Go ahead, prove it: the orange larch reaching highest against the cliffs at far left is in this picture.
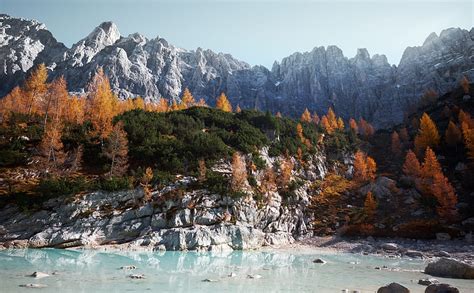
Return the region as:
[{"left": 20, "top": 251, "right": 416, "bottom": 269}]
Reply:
[{"left": 25, "top": 63, "right": 48, "bottom": 114}]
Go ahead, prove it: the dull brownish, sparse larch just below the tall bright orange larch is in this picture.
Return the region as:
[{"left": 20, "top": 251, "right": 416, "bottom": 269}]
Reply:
[{"left": 104, "top": 121, "right": 128, "bottom": 177}]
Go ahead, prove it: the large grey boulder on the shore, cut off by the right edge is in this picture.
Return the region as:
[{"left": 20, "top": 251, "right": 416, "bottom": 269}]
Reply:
[{"left": 425, "top": 258, "right": 474, "bottom": 279}]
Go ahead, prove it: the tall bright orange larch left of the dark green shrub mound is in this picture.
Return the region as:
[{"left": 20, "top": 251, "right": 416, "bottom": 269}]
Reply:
[{"left": 87, "top": 68, "right": 117, "bottom": 143}]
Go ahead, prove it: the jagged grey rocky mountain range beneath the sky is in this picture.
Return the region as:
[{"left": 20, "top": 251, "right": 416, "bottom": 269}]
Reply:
[{"left": 0, "top": 15, "right": 474, "bottom": 127}]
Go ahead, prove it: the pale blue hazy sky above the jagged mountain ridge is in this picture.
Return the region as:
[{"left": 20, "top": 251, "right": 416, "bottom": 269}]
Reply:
[{"left": 0, "top": 0, "right": 474, "bottom": 68}]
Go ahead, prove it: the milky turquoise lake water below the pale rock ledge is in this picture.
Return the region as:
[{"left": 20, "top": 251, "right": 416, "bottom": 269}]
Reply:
[{"left": 0, "top": 249, "right": 474, "bottom": 293}]
